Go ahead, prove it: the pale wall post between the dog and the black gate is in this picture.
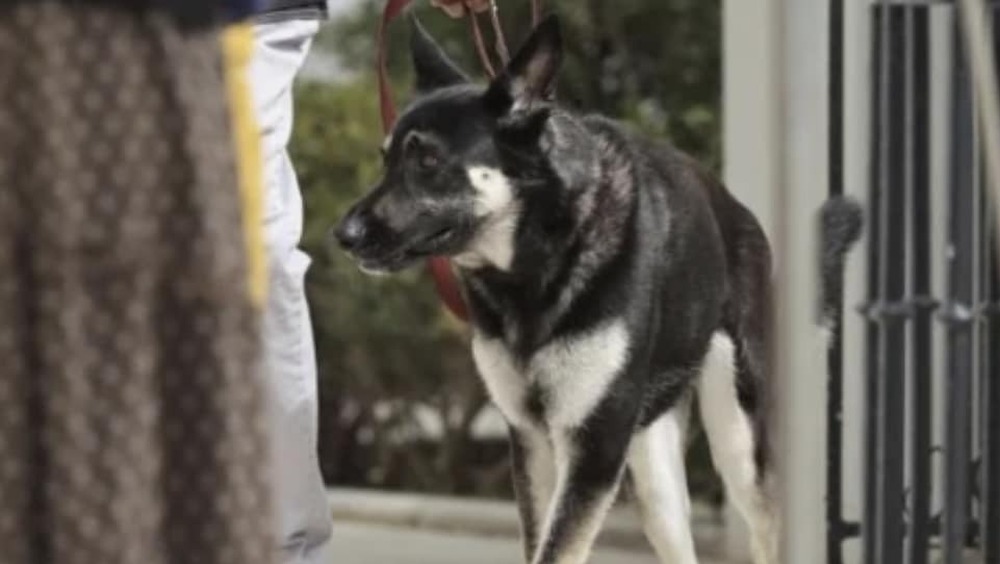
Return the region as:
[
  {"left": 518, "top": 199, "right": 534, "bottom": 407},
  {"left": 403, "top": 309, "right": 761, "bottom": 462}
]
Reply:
[{"left": 723, "top": 0, "right": 829, "bottom": 562}]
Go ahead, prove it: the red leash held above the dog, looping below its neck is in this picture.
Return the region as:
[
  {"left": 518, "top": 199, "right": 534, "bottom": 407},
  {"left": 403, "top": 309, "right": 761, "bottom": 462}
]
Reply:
[{"left": 375, "top": 0, "right": 540, "bottom": 321}]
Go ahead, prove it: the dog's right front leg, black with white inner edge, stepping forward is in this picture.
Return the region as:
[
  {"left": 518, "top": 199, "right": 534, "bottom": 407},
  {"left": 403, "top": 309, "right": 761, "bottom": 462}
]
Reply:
[{"left": 532, "top": 429, "right": 628, "bottom": 564}]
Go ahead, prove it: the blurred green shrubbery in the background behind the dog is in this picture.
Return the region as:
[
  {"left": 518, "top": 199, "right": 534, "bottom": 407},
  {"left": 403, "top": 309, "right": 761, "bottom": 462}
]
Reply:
[{"left": 292, "top": 0, "right": 722, "bottom": 505}]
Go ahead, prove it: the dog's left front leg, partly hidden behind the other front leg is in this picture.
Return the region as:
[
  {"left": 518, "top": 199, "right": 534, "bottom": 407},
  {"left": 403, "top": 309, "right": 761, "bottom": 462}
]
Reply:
[{"left": 510, "top": 427, "right": 556, "bottom": 562}]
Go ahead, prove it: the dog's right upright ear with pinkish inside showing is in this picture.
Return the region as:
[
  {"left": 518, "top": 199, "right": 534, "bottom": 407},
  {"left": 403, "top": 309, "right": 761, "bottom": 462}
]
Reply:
[{"left": 485, "top": 15, "right": 562, "bottom": 115}]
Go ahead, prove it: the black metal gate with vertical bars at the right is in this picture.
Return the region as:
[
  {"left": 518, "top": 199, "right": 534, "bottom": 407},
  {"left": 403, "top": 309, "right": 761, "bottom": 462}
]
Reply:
[{"left": 827, "top": 0, "right": 1000, "bottom": 564}]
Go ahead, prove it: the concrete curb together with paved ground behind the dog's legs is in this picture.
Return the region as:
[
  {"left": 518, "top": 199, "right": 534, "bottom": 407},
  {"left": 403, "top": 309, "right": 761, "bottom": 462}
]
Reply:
[{"left": 329, "top": 488, "right": 746, "bottom": 564}]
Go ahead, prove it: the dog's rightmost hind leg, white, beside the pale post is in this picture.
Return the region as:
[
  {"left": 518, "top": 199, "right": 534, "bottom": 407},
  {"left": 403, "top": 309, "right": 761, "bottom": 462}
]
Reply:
[{"left": 698, "top": 333, "right": 778, "bottom": 564}]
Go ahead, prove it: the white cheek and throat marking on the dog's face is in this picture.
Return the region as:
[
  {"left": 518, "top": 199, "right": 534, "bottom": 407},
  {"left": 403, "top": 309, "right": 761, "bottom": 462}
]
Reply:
[{"left": 455, "top": 166, "right": 520, "bottom": 270}]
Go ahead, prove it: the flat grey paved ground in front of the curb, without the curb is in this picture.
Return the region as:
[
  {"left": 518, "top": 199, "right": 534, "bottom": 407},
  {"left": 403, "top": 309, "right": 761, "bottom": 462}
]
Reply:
[{"left": 333, "top": 522, "right": 720, "bottom": 564}]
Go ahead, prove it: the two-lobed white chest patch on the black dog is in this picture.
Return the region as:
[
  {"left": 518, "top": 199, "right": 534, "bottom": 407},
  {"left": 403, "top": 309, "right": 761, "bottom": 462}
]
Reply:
[{"left": 472, "top": 320, "right": 629, "bottom": 429}]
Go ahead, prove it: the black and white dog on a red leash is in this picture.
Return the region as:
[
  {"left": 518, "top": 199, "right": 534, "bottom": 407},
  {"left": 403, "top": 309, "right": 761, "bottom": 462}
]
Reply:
[{"left": 334, "top": 14, "right": 850, "bottom": 564}]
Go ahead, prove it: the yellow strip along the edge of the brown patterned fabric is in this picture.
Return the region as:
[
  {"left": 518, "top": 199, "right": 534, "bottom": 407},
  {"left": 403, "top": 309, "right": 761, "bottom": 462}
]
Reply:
[{"left": 222, "top": 24, "right": 267, "bottom": 306}]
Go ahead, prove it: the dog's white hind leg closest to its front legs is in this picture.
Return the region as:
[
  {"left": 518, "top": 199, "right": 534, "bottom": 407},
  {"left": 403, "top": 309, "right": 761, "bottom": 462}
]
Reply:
[{"left": 628, "top": 399, "right": 698, "bottom": 564}]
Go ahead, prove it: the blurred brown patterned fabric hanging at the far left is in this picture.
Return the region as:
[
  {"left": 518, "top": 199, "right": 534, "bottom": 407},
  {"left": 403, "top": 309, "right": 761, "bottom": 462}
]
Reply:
[{"left": 0, "top": 1, "right": 273, "bottom": 564}]
